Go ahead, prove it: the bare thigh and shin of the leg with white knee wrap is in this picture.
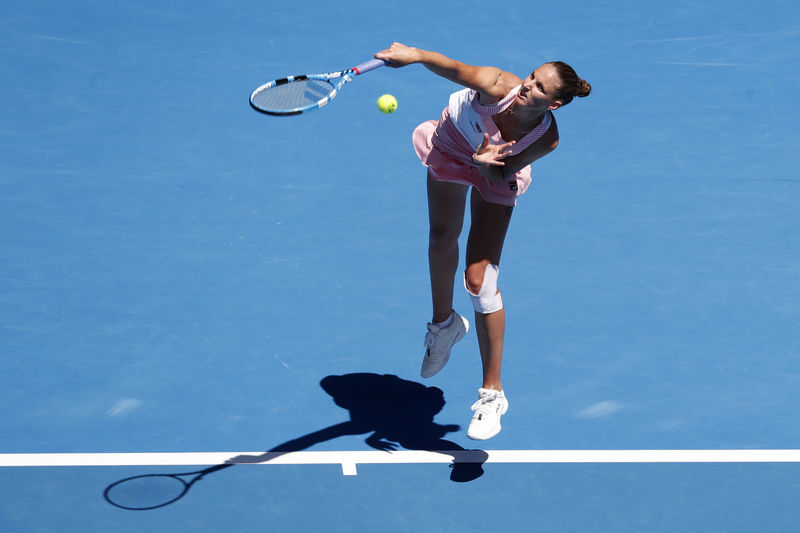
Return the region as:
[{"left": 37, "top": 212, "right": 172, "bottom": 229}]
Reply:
[{"left": 464, "top": 190, "right": 513, "bottom": 390}]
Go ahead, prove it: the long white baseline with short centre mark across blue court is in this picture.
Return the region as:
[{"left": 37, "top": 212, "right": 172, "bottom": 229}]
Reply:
[{"left": 0, "top": 450, "right": 800, "bottom": 476}]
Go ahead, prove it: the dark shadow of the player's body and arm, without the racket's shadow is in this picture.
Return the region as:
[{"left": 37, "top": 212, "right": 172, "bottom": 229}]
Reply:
[{"left": 231, "top": 373, "right": 488, "bottom": 482}]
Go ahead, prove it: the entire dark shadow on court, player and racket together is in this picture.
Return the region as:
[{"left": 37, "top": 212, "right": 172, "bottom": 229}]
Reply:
[{"left": 103, "top": 373, "right": 488, "bottom": 511}]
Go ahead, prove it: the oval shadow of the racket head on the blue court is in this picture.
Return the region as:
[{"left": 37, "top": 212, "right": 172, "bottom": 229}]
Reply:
[{"left": 103, "top": 474, "right": 196, "bottom": 511}]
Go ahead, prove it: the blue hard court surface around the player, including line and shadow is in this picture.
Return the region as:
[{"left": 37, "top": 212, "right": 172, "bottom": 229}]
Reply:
[{"left": 0, "top": 0, "right": 800, "bottom": 533}]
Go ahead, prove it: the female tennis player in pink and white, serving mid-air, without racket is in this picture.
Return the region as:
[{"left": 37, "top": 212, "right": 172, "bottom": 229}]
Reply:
[{"left": 375, "top": 43, "right": 591, "bottom": 440}]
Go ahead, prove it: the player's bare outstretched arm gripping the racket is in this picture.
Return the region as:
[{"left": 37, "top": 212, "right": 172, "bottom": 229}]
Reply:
[{"left": 375, "top": 43, "right": 522, "bottom": 104}]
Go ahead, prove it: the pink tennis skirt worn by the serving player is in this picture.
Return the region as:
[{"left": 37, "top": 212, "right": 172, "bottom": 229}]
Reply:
[{"left": 412, "top": 108, "right": 531, "bottom": 207}]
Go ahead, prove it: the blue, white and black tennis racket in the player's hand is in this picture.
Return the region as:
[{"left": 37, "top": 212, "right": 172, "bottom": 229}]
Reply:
[{"left": 250, "top": 59, "right": 386, "bottom": 116}]
